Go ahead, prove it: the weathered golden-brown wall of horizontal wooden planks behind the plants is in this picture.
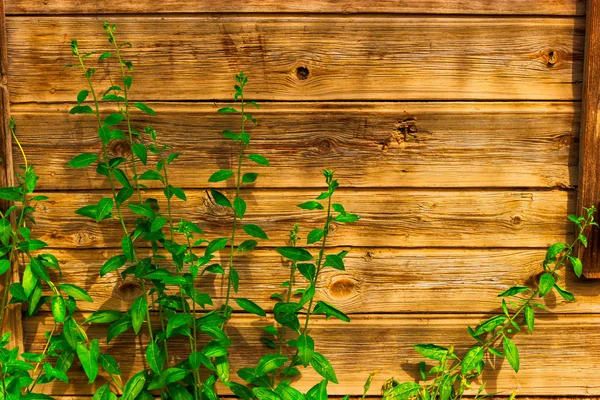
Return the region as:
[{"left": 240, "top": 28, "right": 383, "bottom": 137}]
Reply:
[{"left": 5, "top": 0, "right": 600, "bottom": 399}]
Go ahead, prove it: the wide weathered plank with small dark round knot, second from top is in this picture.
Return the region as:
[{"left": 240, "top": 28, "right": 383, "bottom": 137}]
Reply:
[{"left": 8, "top": 15, "right": 584, "bottom": 102}]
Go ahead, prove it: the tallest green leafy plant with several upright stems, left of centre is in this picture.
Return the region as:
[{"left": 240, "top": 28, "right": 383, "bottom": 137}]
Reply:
[{"left": 62, "top": 23, "right": 358, "bottom": 400}]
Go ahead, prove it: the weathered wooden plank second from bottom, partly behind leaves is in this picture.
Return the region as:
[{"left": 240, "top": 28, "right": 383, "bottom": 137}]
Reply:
[{"left": 29, "top": 248, "right": 600, "bottom": 314}]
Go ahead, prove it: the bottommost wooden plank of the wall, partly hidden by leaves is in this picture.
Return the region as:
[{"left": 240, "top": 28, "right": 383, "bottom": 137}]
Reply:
[{"left": 25, "top": 312, "right": 600, "bottom": 396}]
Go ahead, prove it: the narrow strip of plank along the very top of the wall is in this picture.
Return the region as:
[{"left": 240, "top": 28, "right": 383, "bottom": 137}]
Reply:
[{"left": 7, "top": 0, "right": 585, "bottom": 15}]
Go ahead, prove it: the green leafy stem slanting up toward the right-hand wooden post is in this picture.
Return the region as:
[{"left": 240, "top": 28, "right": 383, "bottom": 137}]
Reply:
[{"left": 383, "top": 207, "right": 598, "bottom": 400}]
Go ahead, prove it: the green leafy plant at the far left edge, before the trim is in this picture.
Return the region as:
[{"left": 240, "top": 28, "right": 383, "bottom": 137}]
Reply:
[{"left": 0, "top": 119, "right": 121, "bottom": 399}]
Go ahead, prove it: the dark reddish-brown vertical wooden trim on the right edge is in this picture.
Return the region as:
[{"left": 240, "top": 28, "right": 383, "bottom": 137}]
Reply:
[{"left": 577, "top": 0, "right": 600, "bottom": 278}]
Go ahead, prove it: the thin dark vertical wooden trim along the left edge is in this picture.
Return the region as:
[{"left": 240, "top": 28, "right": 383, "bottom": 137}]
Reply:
[{"left": 0, "top": 0, "right": 23, "bottom": 350}]
